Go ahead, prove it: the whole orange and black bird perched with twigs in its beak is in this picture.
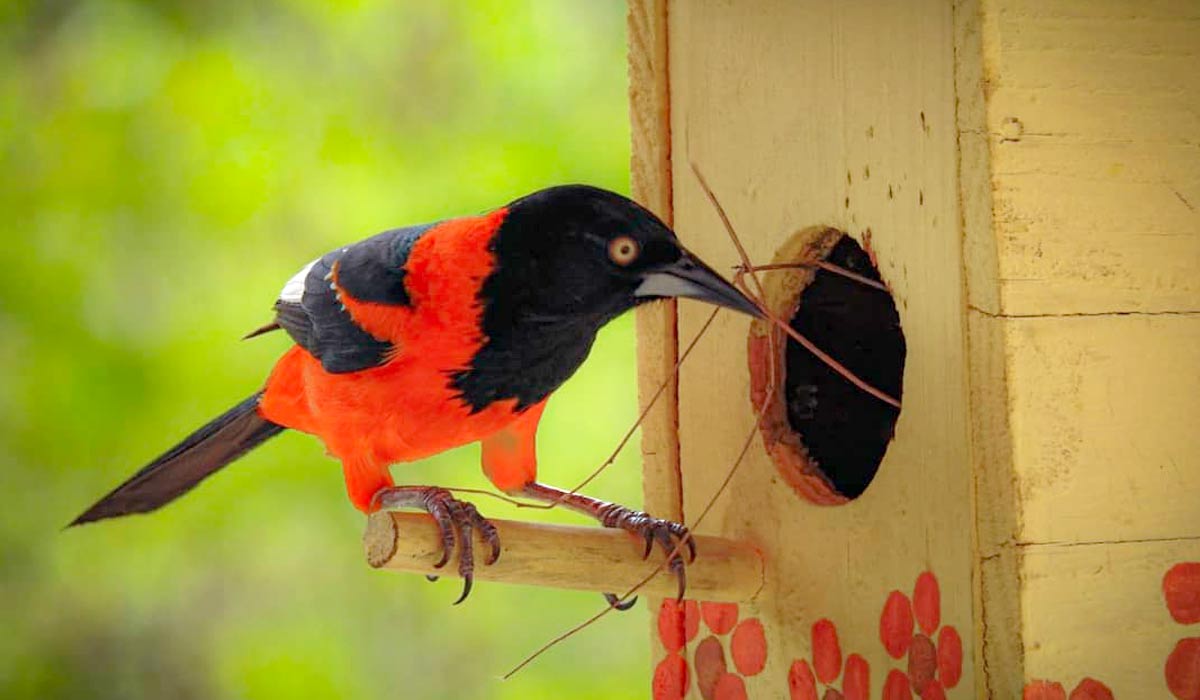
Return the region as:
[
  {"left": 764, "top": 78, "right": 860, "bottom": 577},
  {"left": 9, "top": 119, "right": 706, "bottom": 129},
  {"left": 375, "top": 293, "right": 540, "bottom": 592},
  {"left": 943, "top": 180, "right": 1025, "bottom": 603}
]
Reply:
[{"left": 71, "top": 185, "right": 761, "bottom": 600}]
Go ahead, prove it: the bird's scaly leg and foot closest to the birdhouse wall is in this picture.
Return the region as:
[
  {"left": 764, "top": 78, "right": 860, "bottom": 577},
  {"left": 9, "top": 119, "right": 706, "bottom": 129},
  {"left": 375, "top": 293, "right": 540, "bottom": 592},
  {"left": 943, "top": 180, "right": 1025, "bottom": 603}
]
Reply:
[{"left": 520, "top": 481, "right": 696, "bottom": 604}]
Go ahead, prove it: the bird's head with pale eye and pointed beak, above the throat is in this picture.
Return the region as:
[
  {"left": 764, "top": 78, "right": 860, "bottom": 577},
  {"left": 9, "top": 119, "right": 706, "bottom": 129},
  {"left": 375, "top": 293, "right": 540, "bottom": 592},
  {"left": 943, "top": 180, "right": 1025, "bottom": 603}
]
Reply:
[{"left": 494, "top": 185, "right": 761, "bottom": 323}]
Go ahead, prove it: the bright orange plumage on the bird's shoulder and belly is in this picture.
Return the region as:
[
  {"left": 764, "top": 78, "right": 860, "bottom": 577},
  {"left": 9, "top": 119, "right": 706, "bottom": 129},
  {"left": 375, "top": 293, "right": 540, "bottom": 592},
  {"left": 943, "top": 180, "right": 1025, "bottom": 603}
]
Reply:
[{"left": 259, "top": 209, "right": 528, "bottom": 466}]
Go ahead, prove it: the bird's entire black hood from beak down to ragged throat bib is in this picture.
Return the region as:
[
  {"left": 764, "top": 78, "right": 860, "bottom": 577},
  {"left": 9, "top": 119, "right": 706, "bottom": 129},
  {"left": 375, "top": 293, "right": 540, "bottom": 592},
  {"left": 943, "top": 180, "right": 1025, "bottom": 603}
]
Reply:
[{"left": 455, "top": 185, "right": 760, "bottom": 409}]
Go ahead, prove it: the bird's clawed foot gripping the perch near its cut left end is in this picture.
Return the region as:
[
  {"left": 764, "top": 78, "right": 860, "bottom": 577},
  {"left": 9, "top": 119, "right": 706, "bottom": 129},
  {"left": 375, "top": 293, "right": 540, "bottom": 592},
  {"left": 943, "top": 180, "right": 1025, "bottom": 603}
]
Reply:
[{"left": 371, "top": 486, "right": 500, "bottom": 605}]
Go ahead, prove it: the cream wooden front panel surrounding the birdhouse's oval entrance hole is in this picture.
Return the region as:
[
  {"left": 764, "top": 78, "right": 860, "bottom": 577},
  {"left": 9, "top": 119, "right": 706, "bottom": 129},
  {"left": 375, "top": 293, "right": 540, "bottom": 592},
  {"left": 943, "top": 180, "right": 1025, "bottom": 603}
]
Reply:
[{"left": 668, "top": 0, "right": 976, "bottom": 698}]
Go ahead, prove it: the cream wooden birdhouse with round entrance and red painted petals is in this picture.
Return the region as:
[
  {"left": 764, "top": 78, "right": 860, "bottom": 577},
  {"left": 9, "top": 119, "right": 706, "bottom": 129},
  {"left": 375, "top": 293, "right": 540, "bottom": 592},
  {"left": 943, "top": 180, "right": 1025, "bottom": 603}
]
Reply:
[{"left": 368, "top": 0, "right": 1200, "bottom": 700}]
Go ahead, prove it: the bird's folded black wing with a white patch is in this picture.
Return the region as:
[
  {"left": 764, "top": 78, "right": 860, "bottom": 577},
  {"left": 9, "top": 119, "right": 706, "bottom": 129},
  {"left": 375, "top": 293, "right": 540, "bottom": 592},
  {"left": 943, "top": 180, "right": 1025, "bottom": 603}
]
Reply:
[{"left": 275, "top": 225, "right": 433, "bottom": 373}]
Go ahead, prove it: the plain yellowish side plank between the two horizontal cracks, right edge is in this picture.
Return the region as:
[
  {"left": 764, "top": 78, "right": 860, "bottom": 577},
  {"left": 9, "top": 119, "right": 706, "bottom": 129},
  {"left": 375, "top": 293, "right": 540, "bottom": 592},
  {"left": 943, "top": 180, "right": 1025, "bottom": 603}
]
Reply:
[{"left": 1006, "top": 313, "right": 1200, "bottom": 543}]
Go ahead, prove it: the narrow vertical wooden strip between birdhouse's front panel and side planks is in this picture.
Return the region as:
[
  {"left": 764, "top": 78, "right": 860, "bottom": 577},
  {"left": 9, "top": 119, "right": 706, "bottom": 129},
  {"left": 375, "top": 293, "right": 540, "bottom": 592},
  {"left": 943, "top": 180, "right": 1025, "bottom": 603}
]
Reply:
[{"left": 954, "top": 0, "right": 1025, "bottom": 698}]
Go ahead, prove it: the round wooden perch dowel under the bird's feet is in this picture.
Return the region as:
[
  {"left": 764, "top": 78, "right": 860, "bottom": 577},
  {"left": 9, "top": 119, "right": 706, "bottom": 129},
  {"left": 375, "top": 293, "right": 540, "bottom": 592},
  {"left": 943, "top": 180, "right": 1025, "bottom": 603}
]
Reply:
[{"left": 362, "top": 513, "right": 763, "bottom": 603}]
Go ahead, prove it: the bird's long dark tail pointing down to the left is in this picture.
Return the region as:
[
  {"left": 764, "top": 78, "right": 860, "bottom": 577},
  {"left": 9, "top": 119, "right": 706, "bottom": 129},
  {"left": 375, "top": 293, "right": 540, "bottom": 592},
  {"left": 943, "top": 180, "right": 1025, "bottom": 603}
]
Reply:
[{"left": 68, "top": 391, "right": 283, "bottom": 527}]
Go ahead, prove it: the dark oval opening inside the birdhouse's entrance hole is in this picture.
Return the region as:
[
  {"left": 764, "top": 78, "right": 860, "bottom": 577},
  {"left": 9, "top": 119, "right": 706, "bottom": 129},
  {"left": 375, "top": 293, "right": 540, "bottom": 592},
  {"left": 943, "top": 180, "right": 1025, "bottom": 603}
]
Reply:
[{"left": 784, "top": 235, "right": 905, "bottom": 498}]
